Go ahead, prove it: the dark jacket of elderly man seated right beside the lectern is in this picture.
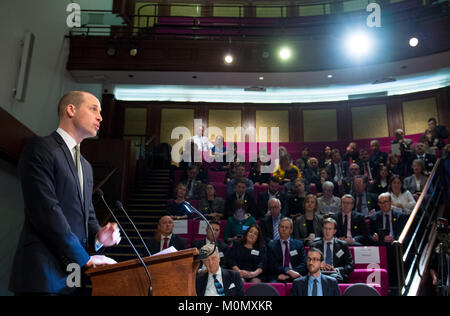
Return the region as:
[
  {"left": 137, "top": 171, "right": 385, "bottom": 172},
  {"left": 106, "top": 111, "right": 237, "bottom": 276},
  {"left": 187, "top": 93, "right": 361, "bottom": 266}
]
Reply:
[{"left": 196, "top": 269, "right": 245, "bottom": 296}]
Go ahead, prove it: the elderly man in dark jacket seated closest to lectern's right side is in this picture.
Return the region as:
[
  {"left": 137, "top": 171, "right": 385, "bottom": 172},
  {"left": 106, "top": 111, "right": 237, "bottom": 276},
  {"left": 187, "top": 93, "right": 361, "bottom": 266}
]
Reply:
[{"left": 196, "top": 244, "right": 244, "bottom": 296}]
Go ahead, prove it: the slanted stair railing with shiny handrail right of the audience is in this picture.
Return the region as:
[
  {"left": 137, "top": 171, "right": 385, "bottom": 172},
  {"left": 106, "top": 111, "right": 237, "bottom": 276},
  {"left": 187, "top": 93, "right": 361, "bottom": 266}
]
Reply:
[{"left": 394, "top": 159, "right": 442, "bottom": 295}]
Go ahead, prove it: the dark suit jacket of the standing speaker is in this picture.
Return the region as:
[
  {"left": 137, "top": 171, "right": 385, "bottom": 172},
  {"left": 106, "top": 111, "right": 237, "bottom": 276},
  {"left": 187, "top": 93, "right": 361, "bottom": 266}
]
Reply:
[{"left": 9, "top": 132, "right": 100, "bottom": 294}]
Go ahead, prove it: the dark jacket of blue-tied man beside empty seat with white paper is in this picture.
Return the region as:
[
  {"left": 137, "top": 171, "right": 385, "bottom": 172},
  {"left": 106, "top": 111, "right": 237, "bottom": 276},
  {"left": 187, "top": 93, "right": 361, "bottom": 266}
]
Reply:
[{"left": 312, "top": 238, "right": 353, "bottom": 282}]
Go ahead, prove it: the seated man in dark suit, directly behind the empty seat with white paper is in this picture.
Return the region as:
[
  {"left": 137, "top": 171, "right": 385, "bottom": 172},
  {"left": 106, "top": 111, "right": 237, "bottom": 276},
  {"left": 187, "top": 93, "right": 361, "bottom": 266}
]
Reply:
[{"left": 334, "top": 194, "right": 369, "bottom": 246}]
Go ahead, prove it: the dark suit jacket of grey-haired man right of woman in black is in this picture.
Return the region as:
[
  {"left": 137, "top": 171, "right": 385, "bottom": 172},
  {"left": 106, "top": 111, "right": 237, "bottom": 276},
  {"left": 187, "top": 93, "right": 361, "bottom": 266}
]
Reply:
[{"left": 267, "top": 238, "right": 306, "bottom": 279}]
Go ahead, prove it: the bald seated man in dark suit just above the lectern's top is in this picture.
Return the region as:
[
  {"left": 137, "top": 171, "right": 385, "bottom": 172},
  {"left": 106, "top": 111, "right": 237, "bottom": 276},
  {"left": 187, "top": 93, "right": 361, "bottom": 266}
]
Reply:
[{"left": 146, "top": 216, "right": 187, "bottom": 254}]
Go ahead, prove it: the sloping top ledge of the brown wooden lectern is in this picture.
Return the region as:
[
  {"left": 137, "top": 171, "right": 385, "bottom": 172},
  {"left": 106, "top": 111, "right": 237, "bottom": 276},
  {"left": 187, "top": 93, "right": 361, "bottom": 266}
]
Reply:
[{"left": 86, "top": 248, "right": 199, "bottom": 276}]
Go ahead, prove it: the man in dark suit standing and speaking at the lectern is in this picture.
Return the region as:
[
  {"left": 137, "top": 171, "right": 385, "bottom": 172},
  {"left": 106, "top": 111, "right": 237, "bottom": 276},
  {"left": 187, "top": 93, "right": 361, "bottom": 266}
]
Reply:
[{"left": 9, "top": 91, "right": 120, "bottom": 295}]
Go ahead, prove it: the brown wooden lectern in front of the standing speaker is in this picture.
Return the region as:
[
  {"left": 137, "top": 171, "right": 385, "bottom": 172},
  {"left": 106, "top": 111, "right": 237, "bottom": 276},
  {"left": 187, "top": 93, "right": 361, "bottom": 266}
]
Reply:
[{"left": 86, "top": 248, "right": 200, "bottom": 296}]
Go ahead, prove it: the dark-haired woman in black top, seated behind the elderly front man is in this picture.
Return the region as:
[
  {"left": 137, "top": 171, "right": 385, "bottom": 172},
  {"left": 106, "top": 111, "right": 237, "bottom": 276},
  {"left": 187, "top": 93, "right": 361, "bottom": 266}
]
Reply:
[{"left": 227, "top": 224, "right": 266, "bottom": 283}]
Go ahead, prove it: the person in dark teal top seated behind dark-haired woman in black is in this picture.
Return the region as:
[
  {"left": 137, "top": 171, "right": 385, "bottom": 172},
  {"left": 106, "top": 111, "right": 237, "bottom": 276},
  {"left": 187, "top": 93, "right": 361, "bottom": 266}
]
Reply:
[{"left": 224, "top": 200, "right": 256, "bottom": 244}]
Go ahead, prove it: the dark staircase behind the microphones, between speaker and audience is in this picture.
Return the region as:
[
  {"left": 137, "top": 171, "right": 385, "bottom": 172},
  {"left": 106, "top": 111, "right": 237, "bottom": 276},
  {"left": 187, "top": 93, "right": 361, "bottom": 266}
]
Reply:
[{"left": 104, "top": 169, "right": 171, "bottom": 262}]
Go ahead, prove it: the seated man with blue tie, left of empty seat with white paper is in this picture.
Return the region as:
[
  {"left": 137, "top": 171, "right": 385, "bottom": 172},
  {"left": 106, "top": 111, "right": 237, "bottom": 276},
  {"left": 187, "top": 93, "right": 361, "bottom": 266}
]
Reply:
[{"left": 312, "top": 218, "right": 353, "bottom": 283}]
